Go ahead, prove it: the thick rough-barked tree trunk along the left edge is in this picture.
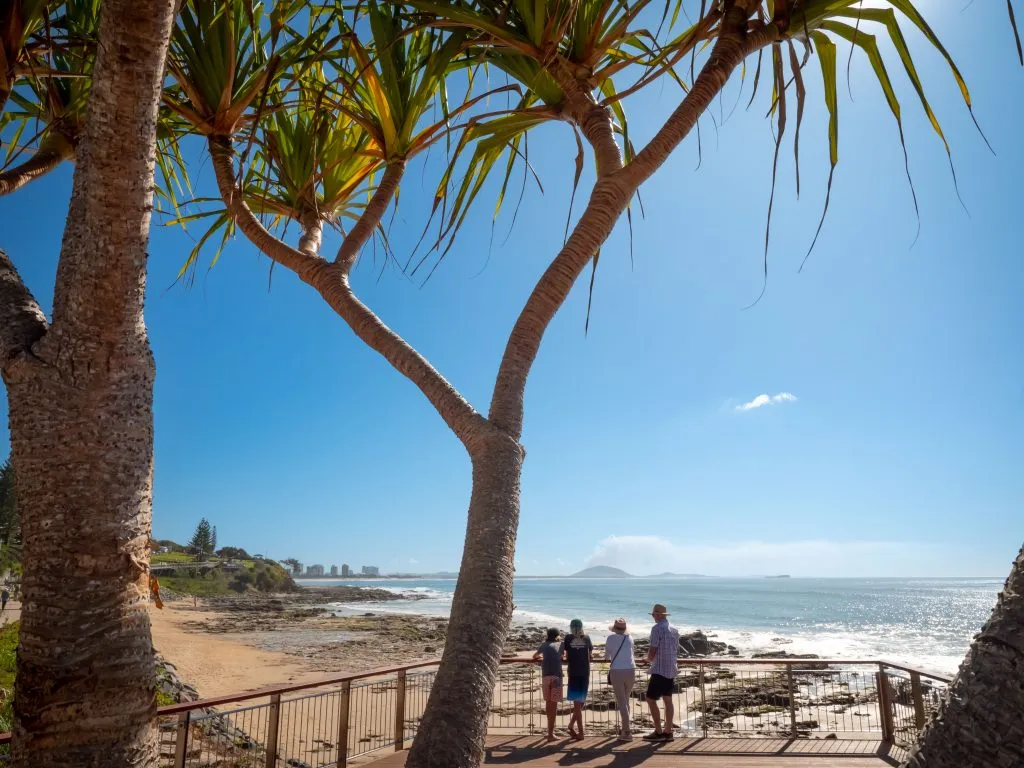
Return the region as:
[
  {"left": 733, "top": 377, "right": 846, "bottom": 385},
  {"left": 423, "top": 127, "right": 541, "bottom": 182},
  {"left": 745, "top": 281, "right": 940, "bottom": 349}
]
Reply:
[{"left": 0, "top": 0, "right": 173, "bottom": 768}]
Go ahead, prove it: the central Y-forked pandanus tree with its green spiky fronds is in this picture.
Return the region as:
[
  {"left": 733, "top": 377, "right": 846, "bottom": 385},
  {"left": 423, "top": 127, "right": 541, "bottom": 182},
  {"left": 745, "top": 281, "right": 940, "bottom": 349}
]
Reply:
[{"left": 159, "top": 0, "right": 1020, "bottom": 768}]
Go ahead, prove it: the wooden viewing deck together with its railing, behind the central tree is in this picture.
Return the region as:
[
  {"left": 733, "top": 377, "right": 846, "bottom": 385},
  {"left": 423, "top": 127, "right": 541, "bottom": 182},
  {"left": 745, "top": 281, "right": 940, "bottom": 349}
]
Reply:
[{"left": 125, "top": 656, "right": 949, "bottom": 768}]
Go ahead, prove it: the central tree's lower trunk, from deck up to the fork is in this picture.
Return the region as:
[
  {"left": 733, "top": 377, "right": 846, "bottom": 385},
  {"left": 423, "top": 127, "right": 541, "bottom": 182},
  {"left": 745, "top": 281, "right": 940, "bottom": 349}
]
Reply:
[{"left": 406, "top": 431, "right": 522, "bottom": 768}]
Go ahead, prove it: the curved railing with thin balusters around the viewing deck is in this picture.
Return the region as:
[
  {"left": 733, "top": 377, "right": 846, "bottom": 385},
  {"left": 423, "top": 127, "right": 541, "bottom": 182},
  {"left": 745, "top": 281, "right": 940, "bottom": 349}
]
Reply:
[{"left": 140, "top": 657, "right": 950, "bottom": 768}]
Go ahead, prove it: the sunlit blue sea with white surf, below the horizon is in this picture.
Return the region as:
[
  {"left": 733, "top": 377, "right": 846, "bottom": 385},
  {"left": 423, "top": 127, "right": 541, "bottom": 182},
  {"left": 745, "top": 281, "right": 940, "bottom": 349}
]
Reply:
[{"left": 304, "top": 578, "right": 1002, "bottom": 674}]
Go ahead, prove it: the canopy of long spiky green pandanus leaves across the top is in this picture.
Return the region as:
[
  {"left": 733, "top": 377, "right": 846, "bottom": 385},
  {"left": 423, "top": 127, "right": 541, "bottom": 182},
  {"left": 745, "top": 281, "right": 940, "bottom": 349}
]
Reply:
[{"left": 0, "top": 0, "right": 1024, "bottom": 275}]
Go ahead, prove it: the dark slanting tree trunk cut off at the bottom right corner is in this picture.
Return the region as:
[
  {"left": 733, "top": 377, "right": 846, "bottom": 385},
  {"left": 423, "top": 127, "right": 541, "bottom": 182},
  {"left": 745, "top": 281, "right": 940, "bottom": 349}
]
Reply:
[{"left": 903, "top": 548, "right": 1024, "bottom": 768}]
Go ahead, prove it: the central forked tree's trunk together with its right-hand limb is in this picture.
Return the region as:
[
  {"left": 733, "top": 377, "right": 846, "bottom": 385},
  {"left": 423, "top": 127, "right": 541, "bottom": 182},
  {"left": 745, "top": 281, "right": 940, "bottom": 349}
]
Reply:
[{"left": 399, "top": 10, "right": 772, "bottom": 768}]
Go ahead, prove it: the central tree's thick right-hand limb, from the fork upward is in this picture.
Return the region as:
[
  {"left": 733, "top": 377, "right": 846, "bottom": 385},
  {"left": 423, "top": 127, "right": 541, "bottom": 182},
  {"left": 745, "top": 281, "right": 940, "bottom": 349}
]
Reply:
[{"left": 488, "top": 0, "right": 770, "bottom": 440}]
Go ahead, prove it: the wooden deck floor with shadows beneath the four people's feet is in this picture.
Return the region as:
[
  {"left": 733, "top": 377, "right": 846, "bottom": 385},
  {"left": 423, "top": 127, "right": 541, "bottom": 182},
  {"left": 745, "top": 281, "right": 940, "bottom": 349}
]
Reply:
[{"left": 361, "top": 736, "right": 904, "bottom": 768}]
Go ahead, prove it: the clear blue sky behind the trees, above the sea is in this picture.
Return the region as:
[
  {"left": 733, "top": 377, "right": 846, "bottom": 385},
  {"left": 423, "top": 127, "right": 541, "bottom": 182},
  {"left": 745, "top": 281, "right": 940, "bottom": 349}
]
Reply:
[{"left": 0, "top": 2, "right": 1024, "bottom": 575}]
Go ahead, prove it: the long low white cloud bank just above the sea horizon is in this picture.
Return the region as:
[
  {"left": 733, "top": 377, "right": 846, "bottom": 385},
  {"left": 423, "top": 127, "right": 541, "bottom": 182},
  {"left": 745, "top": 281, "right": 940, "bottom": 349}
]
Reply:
[{"left": 587, "top": 536, "right": 949, "bottom": 577}]
